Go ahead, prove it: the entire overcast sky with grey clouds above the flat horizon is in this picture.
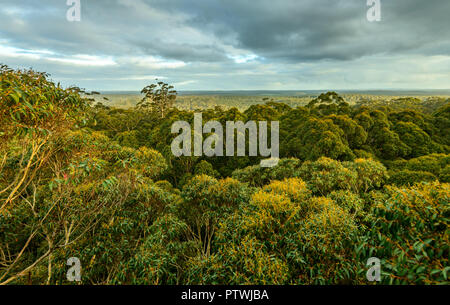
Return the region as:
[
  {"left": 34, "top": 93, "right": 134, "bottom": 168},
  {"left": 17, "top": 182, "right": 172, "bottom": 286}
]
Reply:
[{"left": 0, "top": 0, "right": 450, "bottom": 91}]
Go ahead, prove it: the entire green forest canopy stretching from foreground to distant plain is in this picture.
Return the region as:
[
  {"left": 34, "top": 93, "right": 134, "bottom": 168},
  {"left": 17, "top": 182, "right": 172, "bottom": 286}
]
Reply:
[{"left": 0, "top": 66, "right": 450, "bottom": 284}]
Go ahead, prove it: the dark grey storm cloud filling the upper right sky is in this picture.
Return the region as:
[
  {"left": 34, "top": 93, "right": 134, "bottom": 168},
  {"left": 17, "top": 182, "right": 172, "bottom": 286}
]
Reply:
[{"left": 132, "top": 0, "right": 450, "bottom": 61}]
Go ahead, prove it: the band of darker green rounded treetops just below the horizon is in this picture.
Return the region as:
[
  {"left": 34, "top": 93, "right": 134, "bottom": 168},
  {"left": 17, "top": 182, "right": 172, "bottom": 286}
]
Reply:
[{"left": 92, "top": 92, "right": 450, "bottom": 185}]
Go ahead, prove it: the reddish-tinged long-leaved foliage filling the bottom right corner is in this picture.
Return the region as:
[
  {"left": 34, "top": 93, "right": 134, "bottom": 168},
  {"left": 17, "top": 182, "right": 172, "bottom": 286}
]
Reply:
[{"left": 363, "top": 182, "right": 450, "bottom": 284}]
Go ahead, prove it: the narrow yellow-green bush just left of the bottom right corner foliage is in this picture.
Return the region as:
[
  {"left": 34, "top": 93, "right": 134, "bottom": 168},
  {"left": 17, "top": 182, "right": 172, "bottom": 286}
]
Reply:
[{"left": 295, "top": 197, "right": 358, "bottom": 284}]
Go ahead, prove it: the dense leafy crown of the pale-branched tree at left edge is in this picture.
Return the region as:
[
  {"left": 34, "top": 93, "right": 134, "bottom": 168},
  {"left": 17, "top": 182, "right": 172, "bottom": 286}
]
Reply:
[{"left": 0, "top": 65, "right": 89, "bottom": 142}]
